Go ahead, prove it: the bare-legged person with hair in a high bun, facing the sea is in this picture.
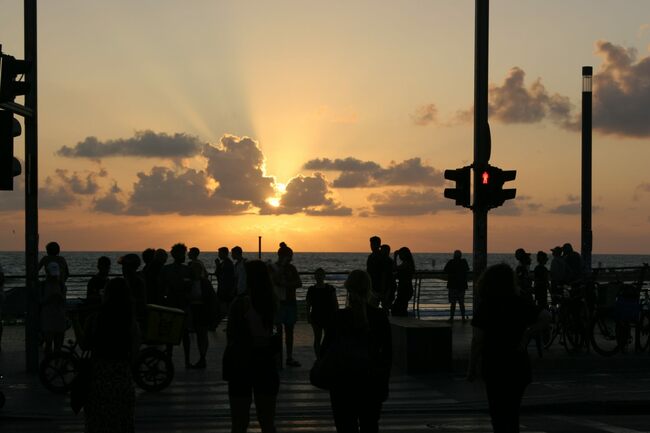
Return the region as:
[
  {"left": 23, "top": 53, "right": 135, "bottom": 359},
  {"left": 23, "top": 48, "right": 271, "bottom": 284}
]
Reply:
[{"left": 268, "top": 242, "right": 302, "bottom": 367}]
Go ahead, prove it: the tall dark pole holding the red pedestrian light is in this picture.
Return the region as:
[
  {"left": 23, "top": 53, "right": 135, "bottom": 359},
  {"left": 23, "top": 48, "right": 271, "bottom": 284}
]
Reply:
[{"left": 473, "top": 0, "right": 490, "bottom": 300}]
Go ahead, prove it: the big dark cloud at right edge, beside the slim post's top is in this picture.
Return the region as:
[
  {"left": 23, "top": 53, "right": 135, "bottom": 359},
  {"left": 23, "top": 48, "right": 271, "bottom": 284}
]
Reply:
[{"left": 593, "top": 41, "right": 650, "bottom": 138}]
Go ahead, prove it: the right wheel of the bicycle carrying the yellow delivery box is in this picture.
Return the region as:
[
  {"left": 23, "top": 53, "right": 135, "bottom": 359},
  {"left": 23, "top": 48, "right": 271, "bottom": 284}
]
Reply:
[{"left": 133, "top": 347, "right": 174, "bottom": 392}]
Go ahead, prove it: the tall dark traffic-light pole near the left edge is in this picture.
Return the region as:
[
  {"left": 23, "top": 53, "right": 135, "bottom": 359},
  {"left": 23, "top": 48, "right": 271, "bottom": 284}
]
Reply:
[{"left": 24, "top": 0, "right": 39, "bottom": 373}]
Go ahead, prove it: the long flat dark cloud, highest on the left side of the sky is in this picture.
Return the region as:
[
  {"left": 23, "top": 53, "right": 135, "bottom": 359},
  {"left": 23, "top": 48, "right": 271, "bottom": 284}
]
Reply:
[{"left": 57, "top": 130, "right": 203, "bottom": 160}]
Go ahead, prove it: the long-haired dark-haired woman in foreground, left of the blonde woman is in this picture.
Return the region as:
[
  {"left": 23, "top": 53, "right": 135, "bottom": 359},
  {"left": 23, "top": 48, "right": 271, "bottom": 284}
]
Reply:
[{"left": 223, "top": 260, "right": 280, "bottom": 433}]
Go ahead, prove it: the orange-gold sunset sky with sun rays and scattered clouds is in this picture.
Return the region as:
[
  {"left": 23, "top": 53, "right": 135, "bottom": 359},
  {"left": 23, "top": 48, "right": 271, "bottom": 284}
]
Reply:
[{"left": 0, "top": 0, "right": 650, "bottom": 253}]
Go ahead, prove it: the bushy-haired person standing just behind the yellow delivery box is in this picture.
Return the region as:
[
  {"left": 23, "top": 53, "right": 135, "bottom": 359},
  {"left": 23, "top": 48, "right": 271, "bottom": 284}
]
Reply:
[{"left": 159, "top": 243, "right": 192, "bottom": 368}]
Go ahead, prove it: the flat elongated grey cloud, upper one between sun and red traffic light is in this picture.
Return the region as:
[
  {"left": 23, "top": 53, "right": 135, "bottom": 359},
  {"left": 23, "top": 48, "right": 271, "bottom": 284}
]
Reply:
[{"left": 304, "top": 157, "right": 444, "bottom": 188}]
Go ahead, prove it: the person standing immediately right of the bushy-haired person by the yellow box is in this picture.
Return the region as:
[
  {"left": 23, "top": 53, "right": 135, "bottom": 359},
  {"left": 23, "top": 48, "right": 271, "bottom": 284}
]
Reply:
[{"left": 190, "top": 261, "right": 216, "bottom": 369}]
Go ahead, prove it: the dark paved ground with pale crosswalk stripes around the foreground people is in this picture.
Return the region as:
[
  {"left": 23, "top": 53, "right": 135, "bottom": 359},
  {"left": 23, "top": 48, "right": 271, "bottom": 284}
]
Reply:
[{"left": 0, "top": 322, "right": 650, "bottom": 432}]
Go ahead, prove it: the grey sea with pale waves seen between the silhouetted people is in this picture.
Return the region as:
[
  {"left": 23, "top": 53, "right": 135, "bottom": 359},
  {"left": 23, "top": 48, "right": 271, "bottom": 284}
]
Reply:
[{"left": 0, "top": 251, "right": 650, "bottom": 319}]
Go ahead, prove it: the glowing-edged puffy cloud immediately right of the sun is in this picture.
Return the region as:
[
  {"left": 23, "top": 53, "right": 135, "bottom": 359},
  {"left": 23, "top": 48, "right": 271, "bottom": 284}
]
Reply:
[{"left": 262, "top": 173, "right": 352, "bottom": 216}]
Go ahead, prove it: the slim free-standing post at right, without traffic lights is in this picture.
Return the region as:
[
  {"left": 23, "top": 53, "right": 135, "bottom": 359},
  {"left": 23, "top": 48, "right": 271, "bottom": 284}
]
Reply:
[{"left": 580, "top": 66, "right": 593, "bottom": 274}]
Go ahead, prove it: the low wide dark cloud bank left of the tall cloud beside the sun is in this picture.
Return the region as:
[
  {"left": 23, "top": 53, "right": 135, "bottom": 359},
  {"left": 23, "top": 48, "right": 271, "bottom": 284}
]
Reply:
[{"left": 125, "top": 167, "right": 249, "bottom": 215}]
